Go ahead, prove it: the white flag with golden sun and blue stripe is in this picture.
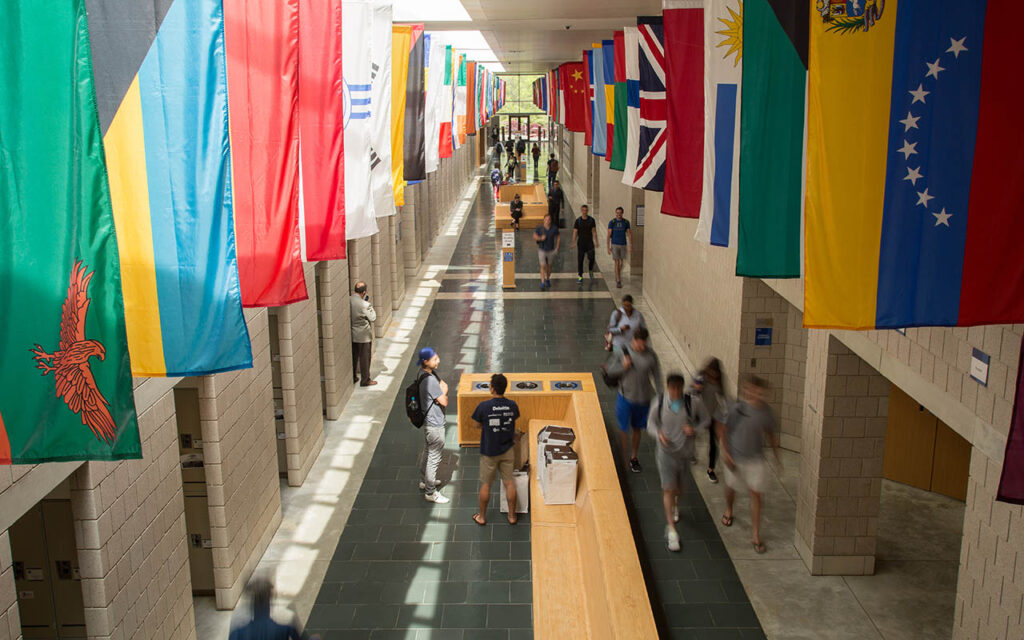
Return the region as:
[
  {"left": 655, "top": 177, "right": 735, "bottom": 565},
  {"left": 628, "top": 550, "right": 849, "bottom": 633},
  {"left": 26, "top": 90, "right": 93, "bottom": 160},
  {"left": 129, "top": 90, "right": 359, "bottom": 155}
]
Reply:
[{"left": 693, "top": 0, "right": 743, "bottom": 247}]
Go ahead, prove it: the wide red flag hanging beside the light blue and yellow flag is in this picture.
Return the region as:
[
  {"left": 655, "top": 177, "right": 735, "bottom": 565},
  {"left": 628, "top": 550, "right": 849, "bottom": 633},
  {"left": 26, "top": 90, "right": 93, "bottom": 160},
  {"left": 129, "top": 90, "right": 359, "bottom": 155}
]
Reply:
[{"left": 224, "top": 0, "right": 309, "bottom": 307}]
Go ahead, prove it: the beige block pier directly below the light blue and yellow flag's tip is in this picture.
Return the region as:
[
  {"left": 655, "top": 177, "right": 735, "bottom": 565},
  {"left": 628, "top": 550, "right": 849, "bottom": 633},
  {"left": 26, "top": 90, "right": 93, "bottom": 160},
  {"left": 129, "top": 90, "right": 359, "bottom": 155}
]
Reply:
[{"left": 195, "top": 309, "right": 281, "bottom": 609}]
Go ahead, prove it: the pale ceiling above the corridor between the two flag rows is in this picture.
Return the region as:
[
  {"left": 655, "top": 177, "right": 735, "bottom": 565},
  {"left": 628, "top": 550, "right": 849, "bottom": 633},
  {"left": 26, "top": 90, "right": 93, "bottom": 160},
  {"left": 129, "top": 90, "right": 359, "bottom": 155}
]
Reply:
[{"left": 395, "top": 0, "right": 662, "bottom": 74}]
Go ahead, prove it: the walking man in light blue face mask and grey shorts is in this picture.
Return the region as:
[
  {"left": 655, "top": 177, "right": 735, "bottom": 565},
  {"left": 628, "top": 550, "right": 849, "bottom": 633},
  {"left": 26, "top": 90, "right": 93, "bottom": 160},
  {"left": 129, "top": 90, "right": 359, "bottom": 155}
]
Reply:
[{"left": 647, "top": 374, "right": 711, "bottom": 551}]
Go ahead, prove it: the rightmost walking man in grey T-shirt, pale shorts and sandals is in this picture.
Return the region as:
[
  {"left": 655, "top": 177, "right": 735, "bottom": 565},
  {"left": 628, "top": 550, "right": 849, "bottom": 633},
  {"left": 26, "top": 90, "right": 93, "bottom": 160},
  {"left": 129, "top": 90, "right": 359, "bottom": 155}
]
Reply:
[{"left": 718, "top": 376, "right": 782, "bottom": 553}]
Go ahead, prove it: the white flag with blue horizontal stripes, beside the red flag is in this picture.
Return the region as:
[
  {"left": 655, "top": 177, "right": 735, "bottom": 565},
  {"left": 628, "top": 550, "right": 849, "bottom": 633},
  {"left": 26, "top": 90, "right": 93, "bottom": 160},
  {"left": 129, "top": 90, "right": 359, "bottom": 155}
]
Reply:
[{"left": 341, "top": 0, "right": 379, "bottom": 240}]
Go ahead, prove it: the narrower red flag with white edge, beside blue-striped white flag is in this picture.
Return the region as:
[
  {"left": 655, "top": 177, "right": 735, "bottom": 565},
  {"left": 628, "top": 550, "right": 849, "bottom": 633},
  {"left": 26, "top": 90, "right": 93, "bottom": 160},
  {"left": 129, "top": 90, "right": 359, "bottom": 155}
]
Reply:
[{"left": 298, "top": 0, "right": 345, "bottom": 260}]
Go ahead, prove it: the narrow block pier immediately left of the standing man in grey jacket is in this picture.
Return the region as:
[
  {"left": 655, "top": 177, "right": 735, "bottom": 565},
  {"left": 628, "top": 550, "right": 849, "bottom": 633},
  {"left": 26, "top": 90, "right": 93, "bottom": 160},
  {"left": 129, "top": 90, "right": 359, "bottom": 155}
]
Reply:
[{"left": 316, "top": 260, "right": 352, "bottom": 420}]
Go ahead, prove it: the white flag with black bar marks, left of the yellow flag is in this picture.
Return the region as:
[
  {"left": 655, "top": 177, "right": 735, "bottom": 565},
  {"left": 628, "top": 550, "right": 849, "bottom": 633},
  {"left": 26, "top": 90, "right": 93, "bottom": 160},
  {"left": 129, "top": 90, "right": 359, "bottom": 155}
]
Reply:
[{"left": 370, "top": 0, "right": 393, "bottom": 218}]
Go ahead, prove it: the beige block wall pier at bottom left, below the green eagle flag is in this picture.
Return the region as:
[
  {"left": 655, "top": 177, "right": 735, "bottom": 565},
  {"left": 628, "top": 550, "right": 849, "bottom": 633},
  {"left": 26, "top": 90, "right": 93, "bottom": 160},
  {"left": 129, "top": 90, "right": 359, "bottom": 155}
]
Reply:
[{"left": 71, "top": 389, "right": 196, "bottom": 639}]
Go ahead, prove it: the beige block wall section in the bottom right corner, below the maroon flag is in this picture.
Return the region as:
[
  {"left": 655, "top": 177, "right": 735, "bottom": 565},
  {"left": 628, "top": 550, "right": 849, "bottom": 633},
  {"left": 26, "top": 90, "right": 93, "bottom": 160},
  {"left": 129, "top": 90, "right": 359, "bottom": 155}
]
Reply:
[{"left": 953, "top": 447, "right": 1024, "bottom": 640}]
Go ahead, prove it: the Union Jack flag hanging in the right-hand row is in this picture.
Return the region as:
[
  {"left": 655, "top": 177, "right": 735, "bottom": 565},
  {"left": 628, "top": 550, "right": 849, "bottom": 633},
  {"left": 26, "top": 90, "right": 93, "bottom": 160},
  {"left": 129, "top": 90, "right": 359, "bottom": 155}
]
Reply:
[{"left": 635, "top": 16, "right": 668, "bottom": 191}]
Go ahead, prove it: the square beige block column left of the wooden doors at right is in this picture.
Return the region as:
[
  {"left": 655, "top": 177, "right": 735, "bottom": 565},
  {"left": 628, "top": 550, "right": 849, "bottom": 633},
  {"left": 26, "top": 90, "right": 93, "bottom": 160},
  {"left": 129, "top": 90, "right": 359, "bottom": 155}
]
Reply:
[{"left": 796, "top": 331, "right": 890, "bottom": 575}]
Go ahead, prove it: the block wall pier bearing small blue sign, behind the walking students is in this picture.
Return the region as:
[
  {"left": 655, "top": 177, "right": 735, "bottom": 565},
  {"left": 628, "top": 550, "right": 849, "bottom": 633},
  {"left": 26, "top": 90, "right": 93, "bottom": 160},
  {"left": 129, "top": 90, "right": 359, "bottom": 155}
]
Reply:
[{"left": 739, "top": 278, "right": 807, "bottom": 452}]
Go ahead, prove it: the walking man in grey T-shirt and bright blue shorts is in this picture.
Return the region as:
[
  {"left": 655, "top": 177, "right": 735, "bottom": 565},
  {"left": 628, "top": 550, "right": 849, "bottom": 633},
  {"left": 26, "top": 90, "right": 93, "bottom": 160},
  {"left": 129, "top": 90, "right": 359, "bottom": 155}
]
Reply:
[{"left": 608, "top": 327, "right": 664, "bottom": 473}]
